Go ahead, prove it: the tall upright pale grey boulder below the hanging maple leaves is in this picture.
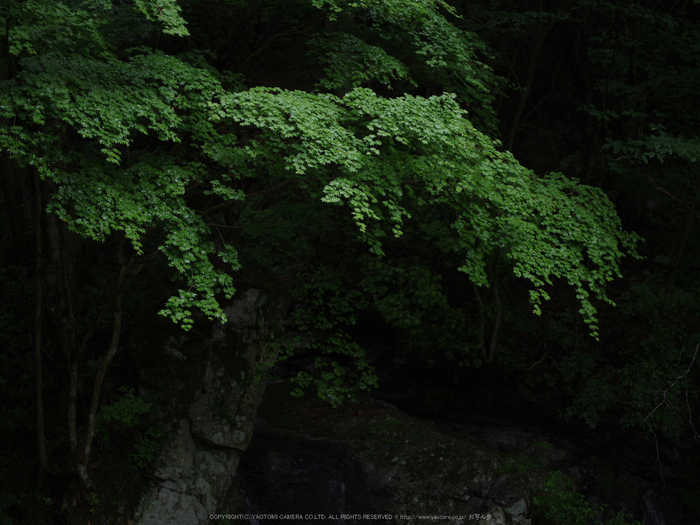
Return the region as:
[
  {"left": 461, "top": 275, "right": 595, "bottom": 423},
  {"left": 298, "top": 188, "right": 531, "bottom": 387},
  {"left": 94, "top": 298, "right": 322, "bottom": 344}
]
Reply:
[{"left": 129, "top": 288, "right": 286, "bottom": 525}]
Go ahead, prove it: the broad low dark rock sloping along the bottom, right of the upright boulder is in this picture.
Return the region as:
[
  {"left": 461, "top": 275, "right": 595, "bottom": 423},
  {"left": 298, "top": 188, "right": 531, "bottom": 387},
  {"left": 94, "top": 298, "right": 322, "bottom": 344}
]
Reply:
[{"left": 238, "top": 381, "right": 676, "bottom": 525}]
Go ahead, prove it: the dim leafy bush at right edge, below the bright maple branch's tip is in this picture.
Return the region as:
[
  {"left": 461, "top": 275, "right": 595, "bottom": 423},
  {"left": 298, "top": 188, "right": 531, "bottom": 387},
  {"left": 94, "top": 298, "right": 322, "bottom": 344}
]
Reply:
[{"left": 559, "top": 273, "right": 700, "bottom": 436}]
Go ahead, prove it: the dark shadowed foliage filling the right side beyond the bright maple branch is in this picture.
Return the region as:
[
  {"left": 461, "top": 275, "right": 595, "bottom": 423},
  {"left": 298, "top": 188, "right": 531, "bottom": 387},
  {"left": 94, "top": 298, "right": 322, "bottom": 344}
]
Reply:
[{"left": 455, "top": 0, "right": 700, "bottom": 435}]
